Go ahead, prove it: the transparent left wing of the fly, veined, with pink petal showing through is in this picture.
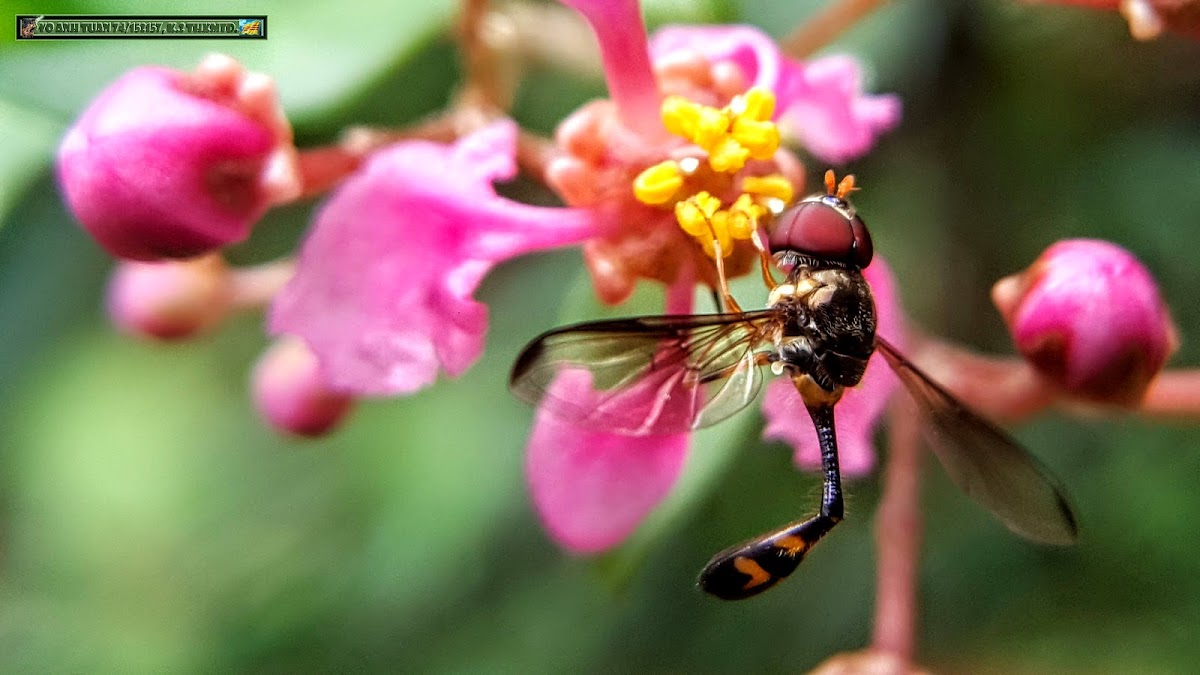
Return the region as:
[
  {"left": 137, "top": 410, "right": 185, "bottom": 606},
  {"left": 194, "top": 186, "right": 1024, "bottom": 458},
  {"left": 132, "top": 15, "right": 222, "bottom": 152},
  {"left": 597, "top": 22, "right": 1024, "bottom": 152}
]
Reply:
[{"left": 509, "top": 310, "right": 776, "bottom": 436}]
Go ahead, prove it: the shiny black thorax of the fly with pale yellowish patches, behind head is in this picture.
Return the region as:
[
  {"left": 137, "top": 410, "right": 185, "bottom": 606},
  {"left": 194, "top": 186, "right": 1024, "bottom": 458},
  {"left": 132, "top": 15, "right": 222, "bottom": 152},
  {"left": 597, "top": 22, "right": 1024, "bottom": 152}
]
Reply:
[{"left": 772, "top": 265, "right": 875, "bottom": 390}]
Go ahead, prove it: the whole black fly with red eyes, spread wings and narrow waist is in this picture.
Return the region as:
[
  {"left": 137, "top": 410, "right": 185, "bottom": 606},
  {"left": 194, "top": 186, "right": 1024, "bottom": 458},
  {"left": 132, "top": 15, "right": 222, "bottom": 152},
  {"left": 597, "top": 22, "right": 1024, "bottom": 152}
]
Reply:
[{"left": 510, "top": 172, "right": 1076, "bottom": 599}]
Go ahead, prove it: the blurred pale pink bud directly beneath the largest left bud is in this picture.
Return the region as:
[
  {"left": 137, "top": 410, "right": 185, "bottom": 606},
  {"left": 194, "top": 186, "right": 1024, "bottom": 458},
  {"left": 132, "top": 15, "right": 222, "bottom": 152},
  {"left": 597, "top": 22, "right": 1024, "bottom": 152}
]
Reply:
[{"left": 108, "top": 256, "right": 232, "bottom": 340}]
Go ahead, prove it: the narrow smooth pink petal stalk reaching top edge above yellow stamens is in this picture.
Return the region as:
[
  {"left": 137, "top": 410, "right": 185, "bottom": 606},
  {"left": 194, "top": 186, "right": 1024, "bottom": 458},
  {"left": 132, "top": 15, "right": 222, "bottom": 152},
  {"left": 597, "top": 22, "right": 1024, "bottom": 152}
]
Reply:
[{"left": 563, "top": 0, "right": 664, "bottom": 138}]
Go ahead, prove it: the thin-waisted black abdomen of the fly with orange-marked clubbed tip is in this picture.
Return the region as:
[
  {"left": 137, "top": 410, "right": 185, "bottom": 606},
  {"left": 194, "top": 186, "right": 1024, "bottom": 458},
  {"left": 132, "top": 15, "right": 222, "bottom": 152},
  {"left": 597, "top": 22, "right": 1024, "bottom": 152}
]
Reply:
[{"left": 700, "top": 405, "right": 845, "bottom": 601}]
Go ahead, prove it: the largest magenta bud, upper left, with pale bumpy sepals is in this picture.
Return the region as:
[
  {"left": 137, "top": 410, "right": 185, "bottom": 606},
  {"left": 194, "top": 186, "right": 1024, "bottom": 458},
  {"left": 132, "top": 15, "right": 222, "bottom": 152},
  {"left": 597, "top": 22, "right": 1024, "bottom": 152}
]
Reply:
[{"left": 58, "top": 55, "right": 300, "bottom": 261}]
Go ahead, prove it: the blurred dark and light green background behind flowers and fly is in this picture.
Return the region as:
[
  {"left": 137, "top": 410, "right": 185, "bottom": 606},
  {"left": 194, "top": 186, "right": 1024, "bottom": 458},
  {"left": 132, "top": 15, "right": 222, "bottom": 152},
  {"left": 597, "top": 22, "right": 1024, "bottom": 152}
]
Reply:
[{"left": 0, "top": 0, "right": 1200, "bottom": 673}]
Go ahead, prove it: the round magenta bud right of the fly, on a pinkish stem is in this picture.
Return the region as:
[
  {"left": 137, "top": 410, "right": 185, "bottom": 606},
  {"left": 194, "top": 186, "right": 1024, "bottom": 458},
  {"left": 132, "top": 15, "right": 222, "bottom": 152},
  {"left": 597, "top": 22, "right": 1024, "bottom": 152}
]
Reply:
[{"left": 991, "top": 239, "right": 1178, "bottom": 406}]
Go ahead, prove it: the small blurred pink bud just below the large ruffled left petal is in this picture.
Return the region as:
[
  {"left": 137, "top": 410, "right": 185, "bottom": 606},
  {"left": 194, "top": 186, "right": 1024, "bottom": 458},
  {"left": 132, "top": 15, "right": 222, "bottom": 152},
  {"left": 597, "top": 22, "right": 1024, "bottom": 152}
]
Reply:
[{"left": 251, "top": 336, "right": 354, "bottom": 436}]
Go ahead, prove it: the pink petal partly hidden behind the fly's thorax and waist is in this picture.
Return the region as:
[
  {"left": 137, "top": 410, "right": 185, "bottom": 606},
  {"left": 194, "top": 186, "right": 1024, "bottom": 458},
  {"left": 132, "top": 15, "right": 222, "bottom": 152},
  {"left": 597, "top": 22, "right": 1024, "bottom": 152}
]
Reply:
[{"left": 762, "top": 255, "right": 904, "bottom": 477}]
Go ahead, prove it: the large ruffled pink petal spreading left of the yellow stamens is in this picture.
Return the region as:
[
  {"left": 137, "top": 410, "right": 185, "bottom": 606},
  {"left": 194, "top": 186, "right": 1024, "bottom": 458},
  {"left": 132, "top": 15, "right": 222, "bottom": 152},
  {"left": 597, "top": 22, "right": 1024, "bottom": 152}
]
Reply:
[{"left": 270, "top": 120, "right": 593, "bottom": 395}]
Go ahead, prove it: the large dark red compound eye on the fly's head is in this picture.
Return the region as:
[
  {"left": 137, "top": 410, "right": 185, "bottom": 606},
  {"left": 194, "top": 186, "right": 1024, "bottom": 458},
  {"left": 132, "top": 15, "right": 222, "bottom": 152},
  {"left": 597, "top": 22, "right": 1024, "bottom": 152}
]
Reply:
[{"left": 768, "top": 198, "right": 871, "bottom": 267}]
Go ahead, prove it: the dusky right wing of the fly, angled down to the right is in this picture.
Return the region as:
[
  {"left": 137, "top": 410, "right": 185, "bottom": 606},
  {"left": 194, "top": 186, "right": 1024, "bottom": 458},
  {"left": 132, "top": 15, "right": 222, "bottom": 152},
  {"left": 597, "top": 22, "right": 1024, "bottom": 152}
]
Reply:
[{"left": 875, "top": 338, "right": 1078, "bottom": 545}]
